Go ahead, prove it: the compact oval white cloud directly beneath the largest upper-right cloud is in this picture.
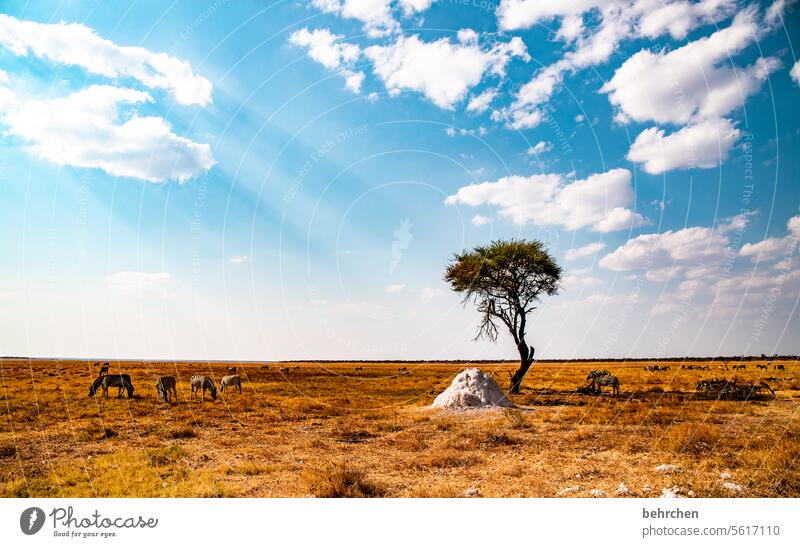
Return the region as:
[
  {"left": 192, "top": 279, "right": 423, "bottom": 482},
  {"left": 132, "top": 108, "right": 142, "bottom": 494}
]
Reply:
[{"left": 627, "top": 119, "right": 741, "bottom": 175}]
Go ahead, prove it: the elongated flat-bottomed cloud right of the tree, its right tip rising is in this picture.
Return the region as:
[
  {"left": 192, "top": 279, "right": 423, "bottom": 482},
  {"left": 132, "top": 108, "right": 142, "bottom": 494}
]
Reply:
[{"left": 600, "top": 216, "right": 747, "bottom": 278}]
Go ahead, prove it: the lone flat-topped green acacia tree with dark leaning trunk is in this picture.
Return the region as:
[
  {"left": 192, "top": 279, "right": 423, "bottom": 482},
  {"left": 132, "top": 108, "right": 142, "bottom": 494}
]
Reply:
[{"left": 444, "top": 240, "right": 561, "bottom": 393}]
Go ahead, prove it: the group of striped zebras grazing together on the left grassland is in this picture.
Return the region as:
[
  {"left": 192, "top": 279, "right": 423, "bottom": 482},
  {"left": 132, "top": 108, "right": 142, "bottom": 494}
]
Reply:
[{"left": 89, "top": 363, "right": 242, "bottom": 403}]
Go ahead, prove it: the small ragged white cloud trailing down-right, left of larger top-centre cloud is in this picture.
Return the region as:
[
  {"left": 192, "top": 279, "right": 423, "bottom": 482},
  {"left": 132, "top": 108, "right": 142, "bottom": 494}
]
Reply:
[{"left": 289, "top": 28, "right": 364, "bottom": 93}]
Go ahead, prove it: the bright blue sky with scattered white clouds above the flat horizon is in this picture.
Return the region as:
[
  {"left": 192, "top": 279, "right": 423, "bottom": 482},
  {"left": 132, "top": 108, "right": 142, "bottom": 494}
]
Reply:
[{"left": 0, "top": 0, "right": 800, "bottom": 359}]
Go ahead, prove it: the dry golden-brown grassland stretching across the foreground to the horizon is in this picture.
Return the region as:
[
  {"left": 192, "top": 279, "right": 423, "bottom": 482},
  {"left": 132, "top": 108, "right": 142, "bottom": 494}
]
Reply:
[{"left": 0, "top": 359, "right": 800, "bottom": 497}]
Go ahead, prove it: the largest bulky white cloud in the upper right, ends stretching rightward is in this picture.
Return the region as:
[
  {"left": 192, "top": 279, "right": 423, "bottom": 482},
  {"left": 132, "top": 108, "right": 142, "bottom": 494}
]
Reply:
[{"left": 601, "top": 9, "right": 779, "bottom": 124}]
